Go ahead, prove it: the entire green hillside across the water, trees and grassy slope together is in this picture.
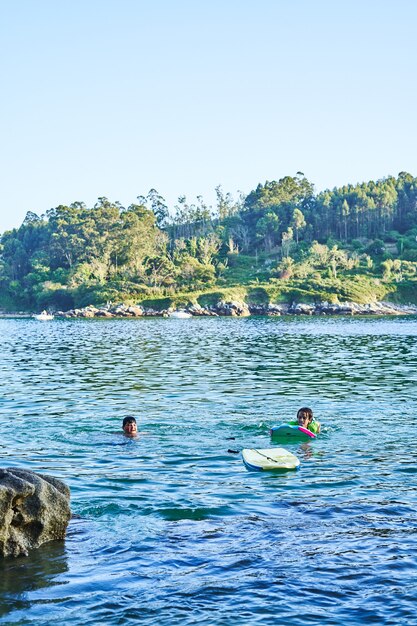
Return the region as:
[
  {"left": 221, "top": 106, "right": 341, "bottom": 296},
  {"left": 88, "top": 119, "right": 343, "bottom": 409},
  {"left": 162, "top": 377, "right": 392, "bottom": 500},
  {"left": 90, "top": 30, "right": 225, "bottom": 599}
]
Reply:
[{"left": 0, "top": 172, "right": 417, "bottom": 310}]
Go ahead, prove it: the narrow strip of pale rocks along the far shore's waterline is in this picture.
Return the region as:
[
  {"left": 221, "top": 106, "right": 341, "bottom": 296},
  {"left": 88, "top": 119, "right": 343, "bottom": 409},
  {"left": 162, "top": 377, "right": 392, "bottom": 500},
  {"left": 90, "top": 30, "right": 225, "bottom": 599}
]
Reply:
[{"left": 51, "top": 301, "right": 417, "bottom": 318}]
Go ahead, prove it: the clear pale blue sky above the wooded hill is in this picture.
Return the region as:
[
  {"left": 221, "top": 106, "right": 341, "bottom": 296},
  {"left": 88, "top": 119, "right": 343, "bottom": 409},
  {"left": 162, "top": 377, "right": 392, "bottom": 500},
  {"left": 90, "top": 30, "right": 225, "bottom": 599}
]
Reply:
[{"left": 0, "top": 0, "right": 417, "bottom": 232}]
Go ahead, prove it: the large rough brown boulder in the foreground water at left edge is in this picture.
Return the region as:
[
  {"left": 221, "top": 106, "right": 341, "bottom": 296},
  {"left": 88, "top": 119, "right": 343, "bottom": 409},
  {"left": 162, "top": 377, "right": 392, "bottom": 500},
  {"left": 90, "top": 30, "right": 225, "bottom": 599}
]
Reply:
[{"left": 0, "top": 468, "right": 71, "bottom": 557}]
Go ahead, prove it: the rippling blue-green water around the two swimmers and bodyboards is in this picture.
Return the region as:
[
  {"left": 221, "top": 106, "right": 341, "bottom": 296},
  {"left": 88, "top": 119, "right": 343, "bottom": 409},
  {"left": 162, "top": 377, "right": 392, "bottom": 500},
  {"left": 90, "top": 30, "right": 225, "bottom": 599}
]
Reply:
[{"left": 0, "top": 317, "right": 417, "bottom": 626}]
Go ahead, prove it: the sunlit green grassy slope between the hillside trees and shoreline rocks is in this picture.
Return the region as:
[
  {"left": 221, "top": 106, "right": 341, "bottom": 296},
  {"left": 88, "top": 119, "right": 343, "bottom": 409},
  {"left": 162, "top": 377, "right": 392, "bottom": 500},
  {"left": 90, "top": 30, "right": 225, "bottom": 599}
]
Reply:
[{"left": 0, "top": 246, "right": 417, "bottom": 311}]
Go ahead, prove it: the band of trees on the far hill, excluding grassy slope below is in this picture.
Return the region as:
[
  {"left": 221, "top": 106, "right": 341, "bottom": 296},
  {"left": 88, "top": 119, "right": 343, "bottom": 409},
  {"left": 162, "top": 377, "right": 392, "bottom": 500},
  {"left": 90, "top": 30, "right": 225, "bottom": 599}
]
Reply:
[{"left": 0, "top": 172, "right": 417, "bottom": 308}]
